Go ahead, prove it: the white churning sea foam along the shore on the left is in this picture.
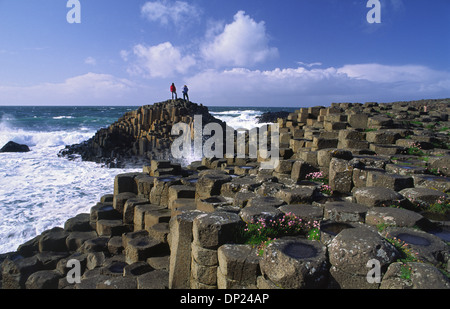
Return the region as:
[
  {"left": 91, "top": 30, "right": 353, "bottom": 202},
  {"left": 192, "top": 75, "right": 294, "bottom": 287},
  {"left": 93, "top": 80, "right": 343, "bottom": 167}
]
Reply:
[{"left": 0, "top": 122, "right": 139, "bottom": 253}]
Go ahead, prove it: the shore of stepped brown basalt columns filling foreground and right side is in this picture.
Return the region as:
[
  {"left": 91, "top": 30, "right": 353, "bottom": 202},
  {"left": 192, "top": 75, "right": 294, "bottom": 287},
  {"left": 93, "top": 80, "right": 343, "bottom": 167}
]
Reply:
[{"left": 0, "top": 99, "right": 450, "bottom": 289}]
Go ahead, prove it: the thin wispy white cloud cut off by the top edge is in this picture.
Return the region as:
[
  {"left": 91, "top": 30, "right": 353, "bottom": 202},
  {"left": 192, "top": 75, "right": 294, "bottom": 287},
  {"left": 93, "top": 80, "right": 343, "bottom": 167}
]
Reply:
[{"left": 141, "top": 0, "right": 201, "bottom": 26}]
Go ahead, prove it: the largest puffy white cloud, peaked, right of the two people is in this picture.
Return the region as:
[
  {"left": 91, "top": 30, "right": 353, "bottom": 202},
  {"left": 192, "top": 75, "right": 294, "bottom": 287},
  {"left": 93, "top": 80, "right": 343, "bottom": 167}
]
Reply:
[{"left": 201, "top": 11, "right": 278, "bottom": 67}]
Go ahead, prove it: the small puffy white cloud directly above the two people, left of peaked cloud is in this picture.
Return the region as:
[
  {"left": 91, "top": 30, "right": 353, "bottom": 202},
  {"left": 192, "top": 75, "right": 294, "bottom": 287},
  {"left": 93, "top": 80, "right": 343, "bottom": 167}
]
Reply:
[{"left": 126, "top": 42, "right": 196, "bottom": 78}]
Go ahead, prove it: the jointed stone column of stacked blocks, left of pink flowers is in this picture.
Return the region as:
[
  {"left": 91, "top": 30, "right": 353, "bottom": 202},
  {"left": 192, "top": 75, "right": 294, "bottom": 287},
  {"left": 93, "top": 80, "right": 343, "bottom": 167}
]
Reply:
[{"left": 190, "top": 212, "right": 243, "bottom": 289}]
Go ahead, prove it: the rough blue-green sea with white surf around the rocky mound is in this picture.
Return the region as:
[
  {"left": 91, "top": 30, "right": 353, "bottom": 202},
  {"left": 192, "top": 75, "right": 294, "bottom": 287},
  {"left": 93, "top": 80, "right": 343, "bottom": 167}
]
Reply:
[{"left": 0, "top": 106, "right": 298, "bottom": 254}]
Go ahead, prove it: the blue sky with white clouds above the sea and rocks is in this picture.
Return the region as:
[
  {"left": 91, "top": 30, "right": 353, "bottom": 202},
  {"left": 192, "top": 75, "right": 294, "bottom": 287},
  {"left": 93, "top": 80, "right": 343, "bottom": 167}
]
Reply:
[{"left": 0, "top": 0, "right": 450, "bottom": 107}]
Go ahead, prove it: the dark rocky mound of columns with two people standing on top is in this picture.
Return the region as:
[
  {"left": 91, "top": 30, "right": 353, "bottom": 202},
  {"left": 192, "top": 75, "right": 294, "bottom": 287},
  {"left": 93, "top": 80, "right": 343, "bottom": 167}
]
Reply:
[{"left": 59, "top": 99, "right": 229, "bottom": 167}]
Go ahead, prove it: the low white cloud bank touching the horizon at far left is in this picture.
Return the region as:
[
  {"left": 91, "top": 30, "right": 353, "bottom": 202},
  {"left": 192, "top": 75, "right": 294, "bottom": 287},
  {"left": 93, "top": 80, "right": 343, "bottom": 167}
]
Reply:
[{"left": 0, "top": 73, "right": 137, "bottom": 105}]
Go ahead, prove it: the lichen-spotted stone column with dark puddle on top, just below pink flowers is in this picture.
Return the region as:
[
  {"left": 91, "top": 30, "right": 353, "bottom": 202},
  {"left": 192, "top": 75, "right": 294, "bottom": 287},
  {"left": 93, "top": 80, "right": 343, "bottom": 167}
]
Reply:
[{"left": 260, "top": 238, "right": 328, "bottom": 289}]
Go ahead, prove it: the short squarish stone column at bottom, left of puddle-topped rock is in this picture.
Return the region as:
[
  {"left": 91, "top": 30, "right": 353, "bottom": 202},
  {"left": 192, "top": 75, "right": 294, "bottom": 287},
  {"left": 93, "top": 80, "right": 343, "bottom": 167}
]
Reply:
[{"left": 217, "top": 244, "right": 261, "bottom": 289}]
